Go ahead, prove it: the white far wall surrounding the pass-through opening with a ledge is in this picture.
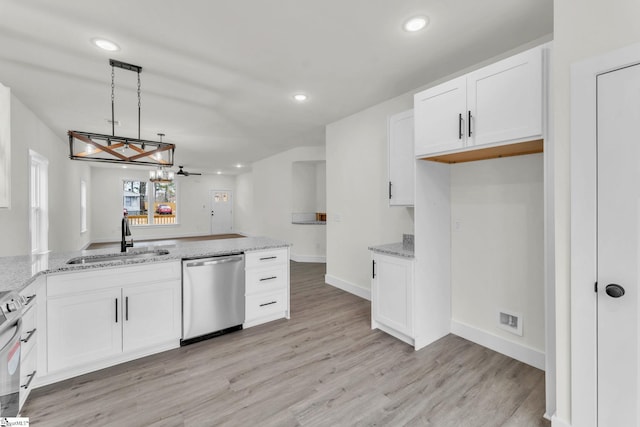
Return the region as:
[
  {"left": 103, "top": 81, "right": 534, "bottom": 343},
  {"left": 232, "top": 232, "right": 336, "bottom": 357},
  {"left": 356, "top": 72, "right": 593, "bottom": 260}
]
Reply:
[{"left": 236, "top": 147, "right": 326, "bottom": 261}]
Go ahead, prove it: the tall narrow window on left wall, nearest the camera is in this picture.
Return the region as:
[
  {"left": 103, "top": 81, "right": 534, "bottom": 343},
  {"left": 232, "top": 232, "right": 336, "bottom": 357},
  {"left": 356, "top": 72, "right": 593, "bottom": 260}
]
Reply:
[{"left": 29, "top": 150, "right": 49, "bottom": 255}]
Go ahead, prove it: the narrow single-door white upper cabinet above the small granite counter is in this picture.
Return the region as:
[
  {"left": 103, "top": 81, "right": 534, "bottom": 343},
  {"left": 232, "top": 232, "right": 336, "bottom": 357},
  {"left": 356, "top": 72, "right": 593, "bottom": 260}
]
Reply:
[{"left": 387, "top": 110, "right": 415, "bottom": 206}]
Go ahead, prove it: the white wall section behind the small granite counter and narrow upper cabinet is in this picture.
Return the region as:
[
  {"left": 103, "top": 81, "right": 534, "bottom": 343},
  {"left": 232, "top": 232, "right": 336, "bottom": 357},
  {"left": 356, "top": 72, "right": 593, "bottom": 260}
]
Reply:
[{"left": 326, "top": 94, "right": 413, "bottom": 297}]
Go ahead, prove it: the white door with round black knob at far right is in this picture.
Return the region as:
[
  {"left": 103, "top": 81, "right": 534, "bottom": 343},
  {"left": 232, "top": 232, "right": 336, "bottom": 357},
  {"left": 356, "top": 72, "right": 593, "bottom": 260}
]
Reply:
[{"left": 597, "top": 61, "right": 640, "bottom": 427}]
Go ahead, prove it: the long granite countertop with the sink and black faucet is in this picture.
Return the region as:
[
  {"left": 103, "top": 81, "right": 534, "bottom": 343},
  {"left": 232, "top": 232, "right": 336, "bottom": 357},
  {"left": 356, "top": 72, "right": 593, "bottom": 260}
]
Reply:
[{"left": 0, "top": 237, "right": 290, "bottom": 291}]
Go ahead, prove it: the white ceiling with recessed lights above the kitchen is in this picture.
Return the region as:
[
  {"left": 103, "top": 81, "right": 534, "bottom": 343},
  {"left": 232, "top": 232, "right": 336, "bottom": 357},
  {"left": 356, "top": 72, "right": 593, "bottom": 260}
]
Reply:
[{"left": 0, "top": 0, "right": 553, "bottom": 173}]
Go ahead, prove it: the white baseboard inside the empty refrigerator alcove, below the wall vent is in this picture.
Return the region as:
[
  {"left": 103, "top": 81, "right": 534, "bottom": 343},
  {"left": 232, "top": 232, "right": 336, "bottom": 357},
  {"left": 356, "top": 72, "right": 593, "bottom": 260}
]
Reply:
[{"left": 451, "top": 320, "right": 545, "bottom": 371}]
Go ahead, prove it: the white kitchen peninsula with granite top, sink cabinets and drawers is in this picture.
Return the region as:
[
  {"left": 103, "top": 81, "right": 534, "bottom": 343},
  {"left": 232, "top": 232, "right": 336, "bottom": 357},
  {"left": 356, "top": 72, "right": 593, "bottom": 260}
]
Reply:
[{"left": 0, "top": 237, "right": 290, "bottom": 405}]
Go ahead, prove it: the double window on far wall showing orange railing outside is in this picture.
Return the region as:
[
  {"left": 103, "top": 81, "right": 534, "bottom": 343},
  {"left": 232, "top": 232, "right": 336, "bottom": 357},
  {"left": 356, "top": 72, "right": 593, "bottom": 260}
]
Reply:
[{"left": 122, "top": 180, "right": 177, "bottom": 225}]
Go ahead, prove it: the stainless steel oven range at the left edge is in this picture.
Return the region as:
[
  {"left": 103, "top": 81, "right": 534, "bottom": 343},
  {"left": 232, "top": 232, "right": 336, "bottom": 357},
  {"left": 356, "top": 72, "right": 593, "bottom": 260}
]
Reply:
[{"left": 0, "top": 291, "right": 24, "bottom": 417}]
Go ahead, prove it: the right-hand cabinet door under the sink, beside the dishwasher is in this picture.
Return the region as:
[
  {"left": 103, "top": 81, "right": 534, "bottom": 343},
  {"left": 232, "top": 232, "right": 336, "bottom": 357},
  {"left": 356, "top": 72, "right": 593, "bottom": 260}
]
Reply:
[{"left": 122, "top": 281, "right": 182, "bottom": 352}]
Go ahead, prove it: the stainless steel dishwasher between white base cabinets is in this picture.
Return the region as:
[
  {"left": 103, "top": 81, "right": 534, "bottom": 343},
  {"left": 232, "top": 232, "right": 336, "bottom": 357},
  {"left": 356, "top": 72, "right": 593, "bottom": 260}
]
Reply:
[{"left": 180, "top": 254, "right": 245, "bottom": 345}]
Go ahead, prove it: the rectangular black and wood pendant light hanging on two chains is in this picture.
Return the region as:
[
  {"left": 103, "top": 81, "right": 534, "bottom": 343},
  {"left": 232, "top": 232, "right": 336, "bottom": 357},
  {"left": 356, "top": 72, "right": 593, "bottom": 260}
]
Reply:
[{"left": 68, "top": 59, "right": 176, "bottom": 167}]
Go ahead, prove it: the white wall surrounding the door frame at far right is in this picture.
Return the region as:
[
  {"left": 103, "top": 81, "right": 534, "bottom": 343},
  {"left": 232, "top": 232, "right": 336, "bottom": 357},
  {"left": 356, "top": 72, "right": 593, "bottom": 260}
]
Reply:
[{"left": 553, "top": 0, "right": 640, "bottom": 425}]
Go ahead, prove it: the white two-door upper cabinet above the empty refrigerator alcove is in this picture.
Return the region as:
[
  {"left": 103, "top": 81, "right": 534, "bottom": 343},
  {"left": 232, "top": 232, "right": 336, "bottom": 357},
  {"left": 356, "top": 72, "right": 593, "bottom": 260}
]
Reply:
[{"left": 414, "top": 47, "right": 543, "bottom": 157}]
